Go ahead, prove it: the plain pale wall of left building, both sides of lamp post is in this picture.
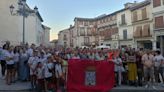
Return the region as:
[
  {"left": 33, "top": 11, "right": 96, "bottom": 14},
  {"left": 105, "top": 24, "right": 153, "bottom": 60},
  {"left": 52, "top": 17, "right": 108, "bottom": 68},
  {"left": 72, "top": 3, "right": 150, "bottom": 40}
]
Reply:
[{"left": 0, "top": 0, "right": 48, "bottom": 45}]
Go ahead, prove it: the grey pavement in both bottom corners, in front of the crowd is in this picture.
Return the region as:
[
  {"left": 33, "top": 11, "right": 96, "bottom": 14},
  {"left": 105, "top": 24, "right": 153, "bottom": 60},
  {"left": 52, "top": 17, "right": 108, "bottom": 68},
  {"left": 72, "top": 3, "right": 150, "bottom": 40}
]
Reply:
[{"left": 0, "top": 67, "right": 164, "bottom": 92}]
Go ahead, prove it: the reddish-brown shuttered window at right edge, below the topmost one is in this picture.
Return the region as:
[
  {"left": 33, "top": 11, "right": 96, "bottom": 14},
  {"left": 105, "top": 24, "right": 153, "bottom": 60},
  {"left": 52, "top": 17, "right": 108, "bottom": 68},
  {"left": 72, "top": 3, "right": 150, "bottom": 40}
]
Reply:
[{"left": 155, "top": 16, "right": 164, "bottom": 29}]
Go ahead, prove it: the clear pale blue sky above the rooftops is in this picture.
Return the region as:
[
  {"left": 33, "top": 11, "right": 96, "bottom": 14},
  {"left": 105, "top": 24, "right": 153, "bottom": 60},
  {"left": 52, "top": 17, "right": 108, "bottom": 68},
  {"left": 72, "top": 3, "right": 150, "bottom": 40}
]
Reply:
[{"left": 27, "top": 0, "right": 143, "bottom": 40}]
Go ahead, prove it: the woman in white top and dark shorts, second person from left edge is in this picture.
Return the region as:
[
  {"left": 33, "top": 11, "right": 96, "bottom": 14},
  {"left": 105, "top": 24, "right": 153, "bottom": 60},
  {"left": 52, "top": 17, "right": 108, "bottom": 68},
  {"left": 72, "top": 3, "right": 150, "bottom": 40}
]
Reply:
[{"left": 5, "top": 46, "right": 14, "bottom": 85}]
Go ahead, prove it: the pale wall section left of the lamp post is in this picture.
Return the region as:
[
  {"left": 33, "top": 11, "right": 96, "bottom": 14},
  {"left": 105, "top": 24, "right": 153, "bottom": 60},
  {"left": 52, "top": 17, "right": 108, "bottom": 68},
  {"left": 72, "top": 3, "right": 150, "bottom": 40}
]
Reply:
[{"left": 0, "top": 0, "right": 22, "bottom": 44}]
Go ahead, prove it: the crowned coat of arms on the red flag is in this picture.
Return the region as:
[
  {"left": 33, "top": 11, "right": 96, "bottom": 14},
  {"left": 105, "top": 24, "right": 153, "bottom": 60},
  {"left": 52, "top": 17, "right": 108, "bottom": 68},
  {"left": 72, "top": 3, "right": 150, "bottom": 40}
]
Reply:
[{"left": 85, "top": 66, "right": 96, "bottom": 86}]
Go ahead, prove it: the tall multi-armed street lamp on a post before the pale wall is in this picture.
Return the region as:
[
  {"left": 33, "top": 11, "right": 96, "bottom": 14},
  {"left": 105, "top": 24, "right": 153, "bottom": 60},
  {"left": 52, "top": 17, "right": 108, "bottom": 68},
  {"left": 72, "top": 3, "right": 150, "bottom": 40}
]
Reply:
[{"left": 9, "top": 0, "right": 35, "bottom": 44}]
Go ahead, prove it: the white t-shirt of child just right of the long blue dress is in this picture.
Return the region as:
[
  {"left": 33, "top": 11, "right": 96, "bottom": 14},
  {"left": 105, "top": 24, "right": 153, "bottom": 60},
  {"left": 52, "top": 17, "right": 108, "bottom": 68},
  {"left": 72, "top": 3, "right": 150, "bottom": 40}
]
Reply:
[{"left": 28, "top": 57, "right": 39, "bottom": 75}]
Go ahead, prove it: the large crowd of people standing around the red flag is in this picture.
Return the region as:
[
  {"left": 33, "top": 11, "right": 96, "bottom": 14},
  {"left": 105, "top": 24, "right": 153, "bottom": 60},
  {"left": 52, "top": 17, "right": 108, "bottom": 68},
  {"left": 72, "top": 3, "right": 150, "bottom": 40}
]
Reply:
[{"left": 0, "top": 42, "right": 164, "bottom": 92}]
